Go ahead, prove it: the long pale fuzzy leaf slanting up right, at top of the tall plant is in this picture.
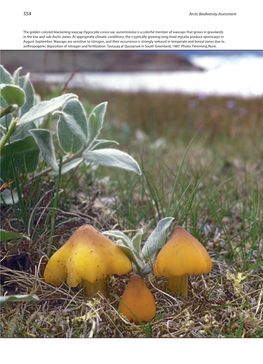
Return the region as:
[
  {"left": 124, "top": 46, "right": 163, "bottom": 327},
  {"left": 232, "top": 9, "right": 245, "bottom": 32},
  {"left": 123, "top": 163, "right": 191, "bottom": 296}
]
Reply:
[{"left": 19, "top": 94, "right": 77, "bottom": 125}]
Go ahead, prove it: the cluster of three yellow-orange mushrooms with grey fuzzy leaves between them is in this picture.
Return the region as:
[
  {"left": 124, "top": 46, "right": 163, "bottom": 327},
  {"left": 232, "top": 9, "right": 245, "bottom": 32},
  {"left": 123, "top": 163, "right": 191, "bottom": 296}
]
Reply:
[{"left": 44, "top": 218, "right": 212, "bottom": 324}]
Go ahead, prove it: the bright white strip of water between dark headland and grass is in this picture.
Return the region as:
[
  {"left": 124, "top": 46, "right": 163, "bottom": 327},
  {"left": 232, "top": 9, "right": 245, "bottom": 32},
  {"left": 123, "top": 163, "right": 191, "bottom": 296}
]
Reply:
[{"left": 31, "top": 60, "right": 263, "bottom": 98}]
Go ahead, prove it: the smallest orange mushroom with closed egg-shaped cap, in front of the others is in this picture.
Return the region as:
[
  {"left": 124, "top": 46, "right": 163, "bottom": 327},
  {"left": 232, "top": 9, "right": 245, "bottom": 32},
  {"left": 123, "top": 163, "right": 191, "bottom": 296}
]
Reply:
[{"left": 119, "top": 274, "right": 156, "bottom": 324}]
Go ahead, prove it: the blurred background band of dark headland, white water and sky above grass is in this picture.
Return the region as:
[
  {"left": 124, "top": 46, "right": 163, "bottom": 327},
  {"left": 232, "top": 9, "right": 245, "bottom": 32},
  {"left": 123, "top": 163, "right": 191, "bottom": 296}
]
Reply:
[{"left": 1, "top": 51, "right": 263, "bottom": 98}]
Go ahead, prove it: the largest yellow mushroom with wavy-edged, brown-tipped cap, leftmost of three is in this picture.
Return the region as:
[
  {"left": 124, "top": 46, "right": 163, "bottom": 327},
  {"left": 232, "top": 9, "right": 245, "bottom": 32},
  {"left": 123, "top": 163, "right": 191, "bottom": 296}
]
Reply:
[{"left": 44, "top": 225, "right": 132, "bottom": 297}]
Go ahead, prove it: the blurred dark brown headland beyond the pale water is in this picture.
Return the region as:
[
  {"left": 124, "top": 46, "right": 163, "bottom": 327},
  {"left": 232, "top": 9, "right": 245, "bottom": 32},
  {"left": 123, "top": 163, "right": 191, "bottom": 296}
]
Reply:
[{"left": 1, "top": 50, "right": 203, "bottom": 74}]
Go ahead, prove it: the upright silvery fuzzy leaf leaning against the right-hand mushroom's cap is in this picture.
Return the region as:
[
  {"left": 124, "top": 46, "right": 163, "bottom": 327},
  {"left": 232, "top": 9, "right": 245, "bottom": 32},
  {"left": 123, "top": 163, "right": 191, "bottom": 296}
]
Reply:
[{"left": 142, "top": 217, "right": 174, "bottom": 259}]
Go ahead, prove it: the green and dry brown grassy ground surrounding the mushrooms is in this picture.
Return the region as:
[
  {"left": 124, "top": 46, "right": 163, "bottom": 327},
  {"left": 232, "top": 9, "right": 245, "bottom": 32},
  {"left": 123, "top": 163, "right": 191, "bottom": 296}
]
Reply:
[{"left": 1, "top": 86, "right": 263, "bottom": 337}]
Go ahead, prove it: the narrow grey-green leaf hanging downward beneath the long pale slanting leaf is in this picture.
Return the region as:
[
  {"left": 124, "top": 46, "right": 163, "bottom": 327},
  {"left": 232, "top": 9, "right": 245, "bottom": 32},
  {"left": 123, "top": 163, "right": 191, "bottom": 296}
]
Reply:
[{"left": 30, "top": 129, "right": 59, "bottom": 172}]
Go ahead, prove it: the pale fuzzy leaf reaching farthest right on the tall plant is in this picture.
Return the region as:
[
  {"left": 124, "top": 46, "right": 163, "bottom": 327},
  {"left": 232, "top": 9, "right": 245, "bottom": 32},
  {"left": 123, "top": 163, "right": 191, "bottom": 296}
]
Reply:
[{"left": 83, "top": 148, "right": 141, "bottom": 174}]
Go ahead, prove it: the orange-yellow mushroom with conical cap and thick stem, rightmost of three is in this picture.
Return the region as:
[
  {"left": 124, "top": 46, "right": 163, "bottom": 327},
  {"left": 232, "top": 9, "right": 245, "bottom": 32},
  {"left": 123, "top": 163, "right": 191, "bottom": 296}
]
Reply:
[{"left": 154, "top": 226, "right": 212, "bottom": 298}]
